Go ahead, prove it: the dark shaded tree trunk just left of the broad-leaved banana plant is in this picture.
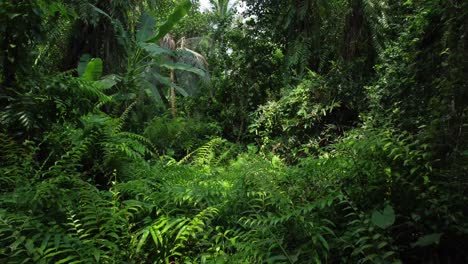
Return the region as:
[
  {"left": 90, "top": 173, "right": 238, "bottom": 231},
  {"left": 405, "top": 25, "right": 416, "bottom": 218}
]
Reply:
[{"left": 63, "top": 0, "right": 154, "bottom": 73}]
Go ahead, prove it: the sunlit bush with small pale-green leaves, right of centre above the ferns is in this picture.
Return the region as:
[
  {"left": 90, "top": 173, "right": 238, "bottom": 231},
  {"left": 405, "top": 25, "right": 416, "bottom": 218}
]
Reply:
[{"left": 250, "top": 72, "right": 356, "bottom": 162}]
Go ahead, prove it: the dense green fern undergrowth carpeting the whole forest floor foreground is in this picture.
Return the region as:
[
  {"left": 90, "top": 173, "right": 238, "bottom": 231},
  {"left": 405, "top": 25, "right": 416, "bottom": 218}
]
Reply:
[{"left": 0, "top": 122, "right": 466, "bottom": 263}]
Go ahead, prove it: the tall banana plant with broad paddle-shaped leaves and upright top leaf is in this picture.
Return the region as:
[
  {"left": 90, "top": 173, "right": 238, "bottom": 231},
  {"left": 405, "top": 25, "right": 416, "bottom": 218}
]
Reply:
[{"left": 130, "top": 1, "right": 207, "bottom": 116}]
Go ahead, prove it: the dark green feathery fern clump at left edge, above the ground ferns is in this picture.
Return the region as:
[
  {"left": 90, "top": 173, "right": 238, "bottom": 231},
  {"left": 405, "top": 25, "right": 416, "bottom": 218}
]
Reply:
[{"left": 0, "top": 73, "right": 110, "bottom": 136}]
